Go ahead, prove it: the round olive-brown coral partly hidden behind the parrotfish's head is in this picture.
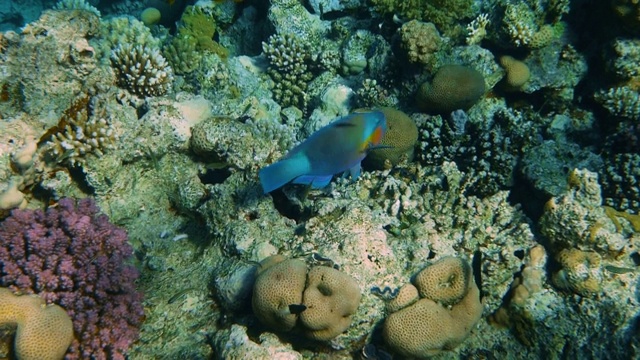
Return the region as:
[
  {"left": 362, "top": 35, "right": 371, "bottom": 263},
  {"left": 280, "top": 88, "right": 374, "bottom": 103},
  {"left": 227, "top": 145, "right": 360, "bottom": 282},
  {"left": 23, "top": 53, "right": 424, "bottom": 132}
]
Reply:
[{"left": 364, "top": 107, "right": 418, "bottom": 170}]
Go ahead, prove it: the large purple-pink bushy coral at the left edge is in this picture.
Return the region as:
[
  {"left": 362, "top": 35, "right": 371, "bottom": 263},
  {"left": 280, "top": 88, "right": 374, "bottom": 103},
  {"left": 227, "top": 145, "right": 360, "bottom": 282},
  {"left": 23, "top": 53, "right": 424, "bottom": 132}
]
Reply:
[{"left": 0, "top": 198, "right": 144, "bottom": 359}]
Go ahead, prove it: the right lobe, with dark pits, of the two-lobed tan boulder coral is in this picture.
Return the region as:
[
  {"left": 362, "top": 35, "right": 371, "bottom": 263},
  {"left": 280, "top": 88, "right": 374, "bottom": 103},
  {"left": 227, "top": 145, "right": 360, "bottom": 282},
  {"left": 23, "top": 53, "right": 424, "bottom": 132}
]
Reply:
[{"left": 300, "top": 266, "right": 361, "bottom": 341}]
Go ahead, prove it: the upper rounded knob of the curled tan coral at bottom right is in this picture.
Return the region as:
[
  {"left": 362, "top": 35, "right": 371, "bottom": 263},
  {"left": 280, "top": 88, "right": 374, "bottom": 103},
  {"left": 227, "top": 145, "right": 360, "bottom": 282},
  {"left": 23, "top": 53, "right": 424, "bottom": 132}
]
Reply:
[{"left": 413, "top": 256, "right": 471, "bottom": 306}]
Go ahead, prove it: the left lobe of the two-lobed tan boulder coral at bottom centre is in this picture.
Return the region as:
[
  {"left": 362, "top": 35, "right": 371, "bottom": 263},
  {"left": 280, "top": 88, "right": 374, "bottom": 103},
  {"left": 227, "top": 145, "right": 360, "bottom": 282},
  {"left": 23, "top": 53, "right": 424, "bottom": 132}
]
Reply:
[{"left": 251, "top": 255, "right": 307, "bottom": 331}]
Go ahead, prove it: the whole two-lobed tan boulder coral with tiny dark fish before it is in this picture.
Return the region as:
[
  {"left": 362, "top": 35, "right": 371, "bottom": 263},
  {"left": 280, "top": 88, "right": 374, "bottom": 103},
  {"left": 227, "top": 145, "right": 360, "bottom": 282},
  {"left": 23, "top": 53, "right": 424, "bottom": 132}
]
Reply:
[{"left": 252, "top": 255, "right": 361, "bottom": 341}]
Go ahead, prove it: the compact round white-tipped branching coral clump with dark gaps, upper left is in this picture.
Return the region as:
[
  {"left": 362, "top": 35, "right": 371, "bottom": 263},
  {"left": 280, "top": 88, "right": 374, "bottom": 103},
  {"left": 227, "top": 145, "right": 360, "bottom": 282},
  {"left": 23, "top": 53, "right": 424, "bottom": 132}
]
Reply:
[{"left": 111, "top": 44, "right": 173, "bottom": 97}]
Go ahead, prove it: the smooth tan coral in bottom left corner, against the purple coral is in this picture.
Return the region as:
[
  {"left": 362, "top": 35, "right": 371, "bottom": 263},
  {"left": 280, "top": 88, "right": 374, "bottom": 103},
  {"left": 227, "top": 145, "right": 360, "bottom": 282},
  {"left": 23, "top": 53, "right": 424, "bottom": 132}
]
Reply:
[{"left": 0, "top": 288, "right": 73, "bottom": 360}]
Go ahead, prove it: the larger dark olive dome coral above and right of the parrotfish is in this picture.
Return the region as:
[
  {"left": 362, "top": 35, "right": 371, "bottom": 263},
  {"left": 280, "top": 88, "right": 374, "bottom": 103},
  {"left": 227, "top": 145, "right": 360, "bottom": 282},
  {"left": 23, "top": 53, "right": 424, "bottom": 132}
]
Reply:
[{"left": 416, "top": 65, "right": 485, "bottom": 114}]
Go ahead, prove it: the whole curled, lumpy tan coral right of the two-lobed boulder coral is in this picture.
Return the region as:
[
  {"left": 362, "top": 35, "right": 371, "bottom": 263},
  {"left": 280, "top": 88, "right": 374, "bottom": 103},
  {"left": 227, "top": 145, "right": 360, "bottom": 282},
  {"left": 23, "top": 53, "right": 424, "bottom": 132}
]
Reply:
[{"left": 382, "top": 257, "right": 483, "bottom": 358}]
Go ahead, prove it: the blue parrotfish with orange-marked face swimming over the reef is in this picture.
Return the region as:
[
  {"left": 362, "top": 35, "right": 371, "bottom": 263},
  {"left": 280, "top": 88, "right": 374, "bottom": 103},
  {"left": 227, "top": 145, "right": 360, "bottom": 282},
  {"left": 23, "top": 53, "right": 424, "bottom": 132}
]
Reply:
[{"left": 259, "top": 111, "right": 387, "bottom": 194}]
